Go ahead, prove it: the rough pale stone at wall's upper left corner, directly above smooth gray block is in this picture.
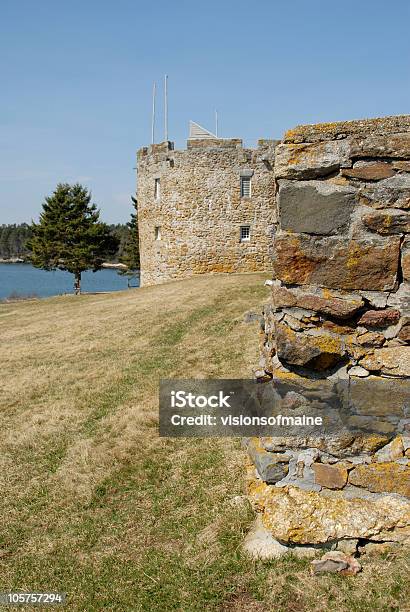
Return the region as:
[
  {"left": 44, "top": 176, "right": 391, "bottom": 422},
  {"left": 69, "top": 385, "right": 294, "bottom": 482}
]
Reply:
[{"left": 275, "top": 140, "right": 351, "bottom": 179}]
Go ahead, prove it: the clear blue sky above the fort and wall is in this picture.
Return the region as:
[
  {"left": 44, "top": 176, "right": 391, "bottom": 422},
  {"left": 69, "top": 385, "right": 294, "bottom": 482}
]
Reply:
[{"left": 0, "top": 0, "right": 410, "bottom": 223}]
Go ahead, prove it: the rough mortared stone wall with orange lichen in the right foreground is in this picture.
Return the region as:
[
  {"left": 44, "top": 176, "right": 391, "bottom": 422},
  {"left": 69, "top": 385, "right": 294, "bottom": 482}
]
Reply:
[{"left": 249, "top": 116, "right": 410, "bottom": 552}]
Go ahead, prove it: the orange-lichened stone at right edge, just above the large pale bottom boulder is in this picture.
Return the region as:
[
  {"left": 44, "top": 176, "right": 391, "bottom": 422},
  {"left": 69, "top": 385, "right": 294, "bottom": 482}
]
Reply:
[{"left": 349, "top": 463, "right": 410, "bottom": 497}]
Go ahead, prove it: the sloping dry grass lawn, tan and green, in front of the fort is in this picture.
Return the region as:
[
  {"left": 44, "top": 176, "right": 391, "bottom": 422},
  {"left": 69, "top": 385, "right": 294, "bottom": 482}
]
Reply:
[{"left": 0, "top": 274, "right": 410, "bottom": 612}]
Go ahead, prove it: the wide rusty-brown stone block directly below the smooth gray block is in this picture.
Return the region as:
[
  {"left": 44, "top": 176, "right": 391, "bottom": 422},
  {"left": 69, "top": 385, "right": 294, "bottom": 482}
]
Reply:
[{"left": 274, "top": 234, "right": 400, "bottom": 291}]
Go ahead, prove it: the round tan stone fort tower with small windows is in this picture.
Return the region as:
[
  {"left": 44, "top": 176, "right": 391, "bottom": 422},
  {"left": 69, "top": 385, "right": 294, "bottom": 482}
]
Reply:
[{"left": 137, "top": 133, "right": 277, "bottom": 286}]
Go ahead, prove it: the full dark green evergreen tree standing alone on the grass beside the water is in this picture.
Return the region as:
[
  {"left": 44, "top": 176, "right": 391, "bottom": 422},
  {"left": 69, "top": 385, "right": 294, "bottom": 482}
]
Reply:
[{"left": 27, "top": 183, "right": 118, "bottom": 294}]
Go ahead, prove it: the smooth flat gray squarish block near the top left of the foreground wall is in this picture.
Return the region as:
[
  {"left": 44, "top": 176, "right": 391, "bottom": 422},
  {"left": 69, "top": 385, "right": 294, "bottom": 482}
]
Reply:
[{"left": 278, "top": 180, "right": 355, "bottom": 236}]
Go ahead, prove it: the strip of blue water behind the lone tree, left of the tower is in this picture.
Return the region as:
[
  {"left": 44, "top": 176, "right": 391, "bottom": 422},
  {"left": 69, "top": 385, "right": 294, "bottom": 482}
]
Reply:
[{"left": 0, "top": 263, "right": 138, "bottom": 300}]
